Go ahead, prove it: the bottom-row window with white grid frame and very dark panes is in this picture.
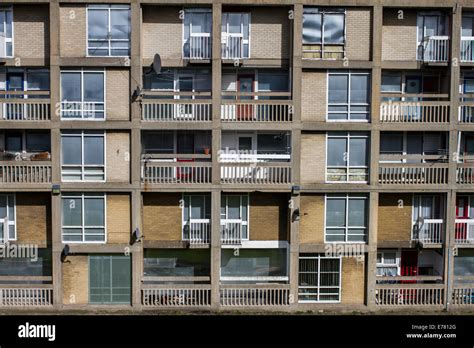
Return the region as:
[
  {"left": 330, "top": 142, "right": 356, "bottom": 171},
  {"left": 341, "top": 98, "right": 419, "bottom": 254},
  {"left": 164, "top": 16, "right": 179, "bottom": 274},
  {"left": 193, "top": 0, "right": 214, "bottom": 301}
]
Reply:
[{"left": 298, "top": 254, "right": 342, "bottom": 303}]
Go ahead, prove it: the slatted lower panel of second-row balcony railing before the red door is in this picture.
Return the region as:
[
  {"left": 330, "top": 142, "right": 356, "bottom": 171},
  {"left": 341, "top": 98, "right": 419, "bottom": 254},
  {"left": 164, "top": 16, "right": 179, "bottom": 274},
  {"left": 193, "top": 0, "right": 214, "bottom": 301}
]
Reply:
[{"left": 221, "top": 100, "right": 293, "bottom": 122}]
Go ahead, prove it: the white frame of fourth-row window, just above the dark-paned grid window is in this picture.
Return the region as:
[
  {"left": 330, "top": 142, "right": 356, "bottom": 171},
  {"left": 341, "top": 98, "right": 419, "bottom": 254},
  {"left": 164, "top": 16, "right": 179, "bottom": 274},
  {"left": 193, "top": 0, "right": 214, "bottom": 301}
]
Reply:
[{"left": 324, "top": 193, "right": 370, "bottom": 244}]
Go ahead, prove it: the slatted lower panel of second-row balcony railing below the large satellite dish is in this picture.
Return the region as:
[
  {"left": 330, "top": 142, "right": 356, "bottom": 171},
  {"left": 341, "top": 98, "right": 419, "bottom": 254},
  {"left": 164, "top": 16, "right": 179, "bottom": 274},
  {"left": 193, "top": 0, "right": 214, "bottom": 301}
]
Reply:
[{"left": 142, "top": 99, "right": 212, "bottom": 122}]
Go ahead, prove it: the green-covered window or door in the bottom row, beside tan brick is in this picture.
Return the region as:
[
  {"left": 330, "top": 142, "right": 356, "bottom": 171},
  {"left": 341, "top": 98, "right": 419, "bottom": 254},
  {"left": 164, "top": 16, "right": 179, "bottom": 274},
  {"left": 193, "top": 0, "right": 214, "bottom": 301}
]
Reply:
[{"left": 89, "top": 255, "right": 131, "bottom": 304}]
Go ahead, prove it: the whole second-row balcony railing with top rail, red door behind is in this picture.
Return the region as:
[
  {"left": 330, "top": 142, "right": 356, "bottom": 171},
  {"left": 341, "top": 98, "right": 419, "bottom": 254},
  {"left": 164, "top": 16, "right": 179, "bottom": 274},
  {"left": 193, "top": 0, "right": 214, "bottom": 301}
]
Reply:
[{"left": 221, "top": 92, "right": 293, "bottom": 122}]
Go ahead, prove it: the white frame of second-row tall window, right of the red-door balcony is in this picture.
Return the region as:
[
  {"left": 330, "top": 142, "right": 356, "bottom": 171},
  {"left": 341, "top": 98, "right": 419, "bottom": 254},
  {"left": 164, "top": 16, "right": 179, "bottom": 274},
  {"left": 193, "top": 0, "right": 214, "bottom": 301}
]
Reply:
[{"left": 326, "top": 70, "right": 372, "bottom": 123}]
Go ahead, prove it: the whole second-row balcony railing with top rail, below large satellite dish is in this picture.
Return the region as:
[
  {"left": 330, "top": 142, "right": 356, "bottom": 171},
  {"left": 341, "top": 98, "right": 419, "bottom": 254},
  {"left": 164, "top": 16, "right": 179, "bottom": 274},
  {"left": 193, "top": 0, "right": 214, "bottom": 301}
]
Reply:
[{"left": 141, "top": 91, "right": 212, "bottom": 122}]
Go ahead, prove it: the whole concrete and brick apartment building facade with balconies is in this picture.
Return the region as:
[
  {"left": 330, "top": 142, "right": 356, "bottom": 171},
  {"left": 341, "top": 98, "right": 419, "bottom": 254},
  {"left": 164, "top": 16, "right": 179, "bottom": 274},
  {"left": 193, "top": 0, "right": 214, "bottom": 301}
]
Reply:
[{"left": 0, "top": 0, "right": 474, "bottom": 311}]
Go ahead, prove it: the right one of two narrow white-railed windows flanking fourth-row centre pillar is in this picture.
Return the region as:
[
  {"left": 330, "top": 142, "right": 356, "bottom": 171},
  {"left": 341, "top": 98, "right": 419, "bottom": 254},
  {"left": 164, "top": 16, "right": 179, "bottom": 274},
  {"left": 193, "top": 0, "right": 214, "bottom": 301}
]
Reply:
[{"left": 221, "top": 195, "right": 249, "bottom": 243}]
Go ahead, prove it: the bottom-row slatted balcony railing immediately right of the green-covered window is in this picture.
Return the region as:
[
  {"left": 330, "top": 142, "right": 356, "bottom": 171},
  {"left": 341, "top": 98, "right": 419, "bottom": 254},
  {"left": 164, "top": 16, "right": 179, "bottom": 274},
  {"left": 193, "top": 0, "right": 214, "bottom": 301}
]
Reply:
[{"left": 142, "top": 285, "right": 211, "bottom": 307}]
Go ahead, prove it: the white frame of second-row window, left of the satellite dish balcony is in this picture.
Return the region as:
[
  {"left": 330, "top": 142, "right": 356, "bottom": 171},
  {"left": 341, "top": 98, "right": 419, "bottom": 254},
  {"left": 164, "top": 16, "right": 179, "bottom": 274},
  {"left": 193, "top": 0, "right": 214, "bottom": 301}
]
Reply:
[{"left": 59, "top": 68, "right": 107, "bottom": 122}]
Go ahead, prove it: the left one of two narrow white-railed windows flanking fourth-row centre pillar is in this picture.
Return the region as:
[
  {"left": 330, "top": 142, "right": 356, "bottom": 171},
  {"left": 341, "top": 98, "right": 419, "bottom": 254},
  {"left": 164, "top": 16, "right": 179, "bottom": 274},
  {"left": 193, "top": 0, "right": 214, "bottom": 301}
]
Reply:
[{"left": 182, "top": 195, "right": 211, "bottom": 243}]
